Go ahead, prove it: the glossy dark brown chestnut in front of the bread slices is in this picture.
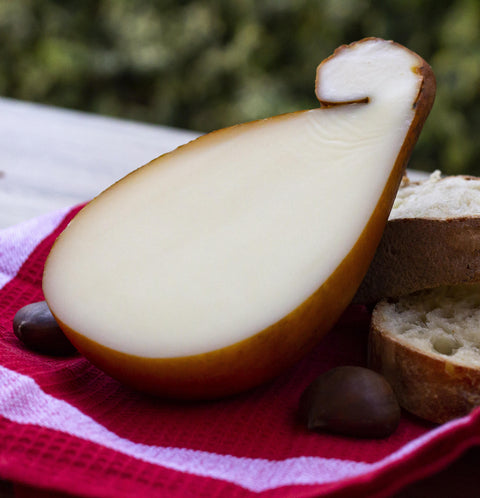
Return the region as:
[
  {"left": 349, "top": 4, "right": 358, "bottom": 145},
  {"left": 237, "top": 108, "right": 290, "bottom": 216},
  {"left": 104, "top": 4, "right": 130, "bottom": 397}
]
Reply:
[{"left": 300, "top": 366, "right": 400, "bottom": 438}]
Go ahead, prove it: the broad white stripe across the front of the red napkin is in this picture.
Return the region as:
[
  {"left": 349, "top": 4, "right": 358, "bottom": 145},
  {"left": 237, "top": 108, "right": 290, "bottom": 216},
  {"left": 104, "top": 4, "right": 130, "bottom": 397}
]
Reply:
[{"left": 0, "top": 366, "right": 371, "bottom": 492}]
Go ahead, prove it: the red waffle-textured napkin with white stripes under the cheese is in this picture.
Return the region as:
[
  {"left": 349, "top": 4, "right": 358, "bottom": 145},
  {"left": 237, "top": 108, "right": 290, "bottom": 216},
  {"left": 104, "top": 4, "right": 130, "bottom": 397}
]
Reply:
[{"left": 0, "top": 204, "right": 480, "bottom": 498}]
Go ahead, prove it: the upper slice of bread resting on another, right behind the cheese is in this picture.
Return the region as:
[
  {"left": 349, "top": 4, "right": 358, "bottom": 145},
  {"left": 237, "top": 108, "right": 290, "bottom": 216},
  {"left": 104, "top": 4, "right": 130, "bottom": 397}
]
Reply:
[{"left": 353, "top": 172, "right": 480, "bottom": 304}]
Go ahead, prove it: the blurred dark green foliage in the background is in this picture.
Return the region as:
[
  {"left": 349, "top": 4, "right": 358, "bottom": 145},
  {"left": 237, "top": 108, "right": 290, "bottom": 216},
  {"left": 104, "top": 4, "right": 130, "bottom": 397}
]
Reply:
[{"left": 0, "top": 0, "right": 480, "bottom": 175}]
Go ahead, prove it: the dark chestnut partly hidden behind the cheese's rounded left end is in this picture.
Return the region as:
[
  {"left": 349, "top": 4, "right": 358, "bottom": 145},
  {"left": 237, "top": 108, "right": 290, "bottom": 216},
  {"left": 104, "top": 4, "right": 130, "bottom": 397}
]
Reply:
[{"left": 13, "top": 301, "right": 76, "bottom": 356}]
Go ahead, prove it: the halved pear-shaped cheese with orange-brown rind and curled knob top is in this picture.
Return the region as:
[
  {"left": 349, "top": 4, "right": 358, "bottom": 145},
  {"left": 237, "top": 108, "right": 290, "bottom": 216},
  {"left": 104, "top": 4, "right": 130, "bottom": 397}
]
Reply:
[{"left": 43, "top": 39, "right": 434, "bottom": 398}]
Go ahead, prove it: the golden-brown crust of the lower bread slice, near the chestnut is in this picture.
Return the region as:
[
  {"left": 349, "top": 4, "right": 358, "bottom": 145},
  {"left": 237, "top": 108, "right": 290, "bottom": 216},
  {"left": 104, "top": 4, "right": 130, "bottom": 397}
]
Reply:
[{"left": 368, "top": 310, "right": 480, "bottom": 423}]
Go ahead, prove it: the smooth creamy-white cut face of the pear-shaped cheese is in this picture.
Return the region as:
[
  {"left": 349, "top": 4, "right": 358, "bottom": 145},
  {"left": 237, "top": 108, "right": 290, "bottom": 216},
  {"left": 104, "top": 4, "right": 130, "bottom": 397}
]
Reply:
[{"left": 44, "top": 40, "right": 419, "bottom": 358}]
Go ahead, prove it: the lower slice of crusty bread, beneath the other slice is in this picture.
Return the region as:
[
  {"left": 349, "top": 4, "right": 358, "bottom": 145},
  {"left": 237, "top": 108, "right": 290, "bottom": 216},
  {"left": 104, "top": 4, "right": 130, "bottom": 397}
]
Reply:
[{"left": 369, "top": 284, "right": 480, "bottom": 423}]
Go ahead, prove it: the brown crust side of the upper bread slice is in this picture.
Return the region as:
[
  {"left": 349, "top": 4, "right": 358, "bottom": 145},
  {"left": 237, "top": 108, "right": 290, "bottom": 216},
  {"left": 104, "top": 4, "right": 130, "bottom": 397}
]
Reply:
[{"left": 353, "top": 217, "right": 480, "bottom": 304}]
